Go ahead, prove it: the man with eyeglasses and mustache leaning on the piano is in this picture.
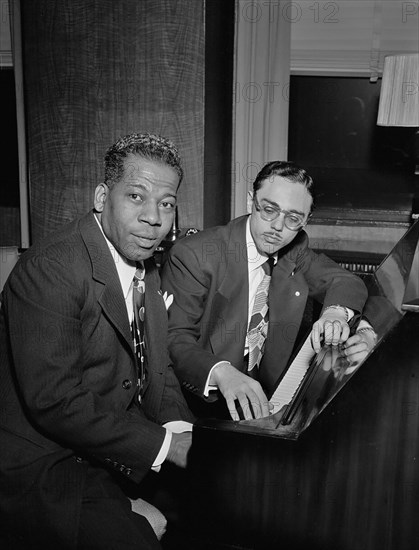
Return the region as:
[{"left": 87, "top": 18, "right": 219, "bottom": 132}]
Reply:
[{"left": 162, "top": 161, "right": 369, "bottom": 420}]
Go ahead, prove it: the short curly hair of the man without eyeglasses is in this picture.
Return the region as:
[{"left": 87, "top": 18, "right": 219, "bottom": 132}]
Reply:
[{"left": 105, "top": 134, "right": 183, "bottom": 187}]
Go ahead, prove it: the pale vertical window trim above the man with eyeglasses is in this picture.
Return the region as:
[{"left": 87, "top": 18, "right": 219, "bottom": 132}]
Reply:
[{"left": 232, "top": 0, "right": 290, "bottom": 217}]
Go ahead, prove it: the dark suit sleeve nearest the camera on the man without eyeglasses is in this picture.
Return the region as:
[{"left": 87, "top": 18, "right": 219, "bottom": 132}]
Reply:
[{"left": 5, "top": 252, "right": 165, "bottom": 481}]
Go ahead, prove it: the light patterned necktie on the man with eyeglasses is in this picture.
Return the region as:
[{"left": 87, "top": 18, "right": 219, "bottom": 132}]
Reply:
[{"left": 247, "top": 258, "right": 274, "bottom": 375}]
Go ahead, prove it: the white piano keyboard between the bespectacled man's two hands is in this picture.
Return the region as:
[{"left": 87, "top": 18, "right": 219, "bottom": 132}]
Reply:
[{"left": 269, "top": 335, "right": 316, "bottom": 414}]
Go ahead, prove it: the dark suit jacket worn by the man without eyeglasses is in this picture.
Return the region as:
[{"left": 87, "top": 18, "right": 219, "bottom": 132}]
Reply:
[{"left": 0, "top": 212, "right": 192, "bottom": 547}]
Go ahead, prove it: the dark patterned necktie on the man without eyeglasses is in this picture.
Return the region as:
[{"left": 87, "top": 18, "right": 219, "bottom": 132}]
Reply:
[{"left": 131, "top": 266, "right": 147, "bottom": 393}]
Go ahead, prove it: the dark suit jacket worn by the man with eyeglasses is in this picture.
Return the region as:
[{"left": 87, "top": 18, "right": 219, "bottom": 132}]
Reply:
[{"left": 162, "top": 216, "right": 367, "bottom": 400}]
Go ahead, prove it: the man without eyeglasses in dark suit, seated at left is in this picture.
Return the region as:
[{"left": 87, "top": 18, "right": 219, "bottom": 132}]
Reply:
[{"left": 0, "top": 134, "right": 193, "bottom": 549}]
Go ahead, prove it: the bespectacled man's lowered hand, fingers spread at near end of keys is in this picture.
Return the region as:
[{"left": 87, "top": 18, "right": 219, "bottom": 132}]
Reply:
[{"left": 210, "top": 363, "right": 270, "bottom": 420}]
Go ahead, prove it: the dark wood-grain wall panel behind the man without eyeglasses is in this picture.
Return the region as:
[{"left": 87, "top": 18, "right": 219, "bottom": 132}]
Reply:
[{"left": 22, "top": 0, "right": 205, "bottom": 242}]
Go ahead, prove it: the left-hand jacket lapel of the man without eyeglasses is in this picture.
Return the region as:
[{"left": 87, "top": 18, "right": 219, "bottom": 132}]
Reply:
[{"left": 80, "top": 212, "right": 133, "bottom": 352}]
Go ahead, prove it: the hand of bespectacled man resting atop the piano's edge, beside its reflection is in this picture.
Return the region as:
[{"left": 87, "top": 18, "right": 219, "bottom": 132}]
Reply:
[{"left": 311, "top": 306, "right": 350, "bottom": 353}]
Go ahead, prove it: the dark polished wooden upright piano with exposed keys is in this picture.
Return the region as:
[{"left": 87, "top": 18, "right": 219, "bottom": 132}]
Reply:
[{"left": 184, "top": 222, "right": 419, "bottom": 550}]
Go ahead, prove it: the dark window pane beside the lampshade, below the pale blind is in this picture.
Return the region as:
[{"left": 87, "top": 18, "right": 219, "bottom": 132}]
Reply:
[{"left": 288, "top": 76, "right": 415, "bottom": 207}]
